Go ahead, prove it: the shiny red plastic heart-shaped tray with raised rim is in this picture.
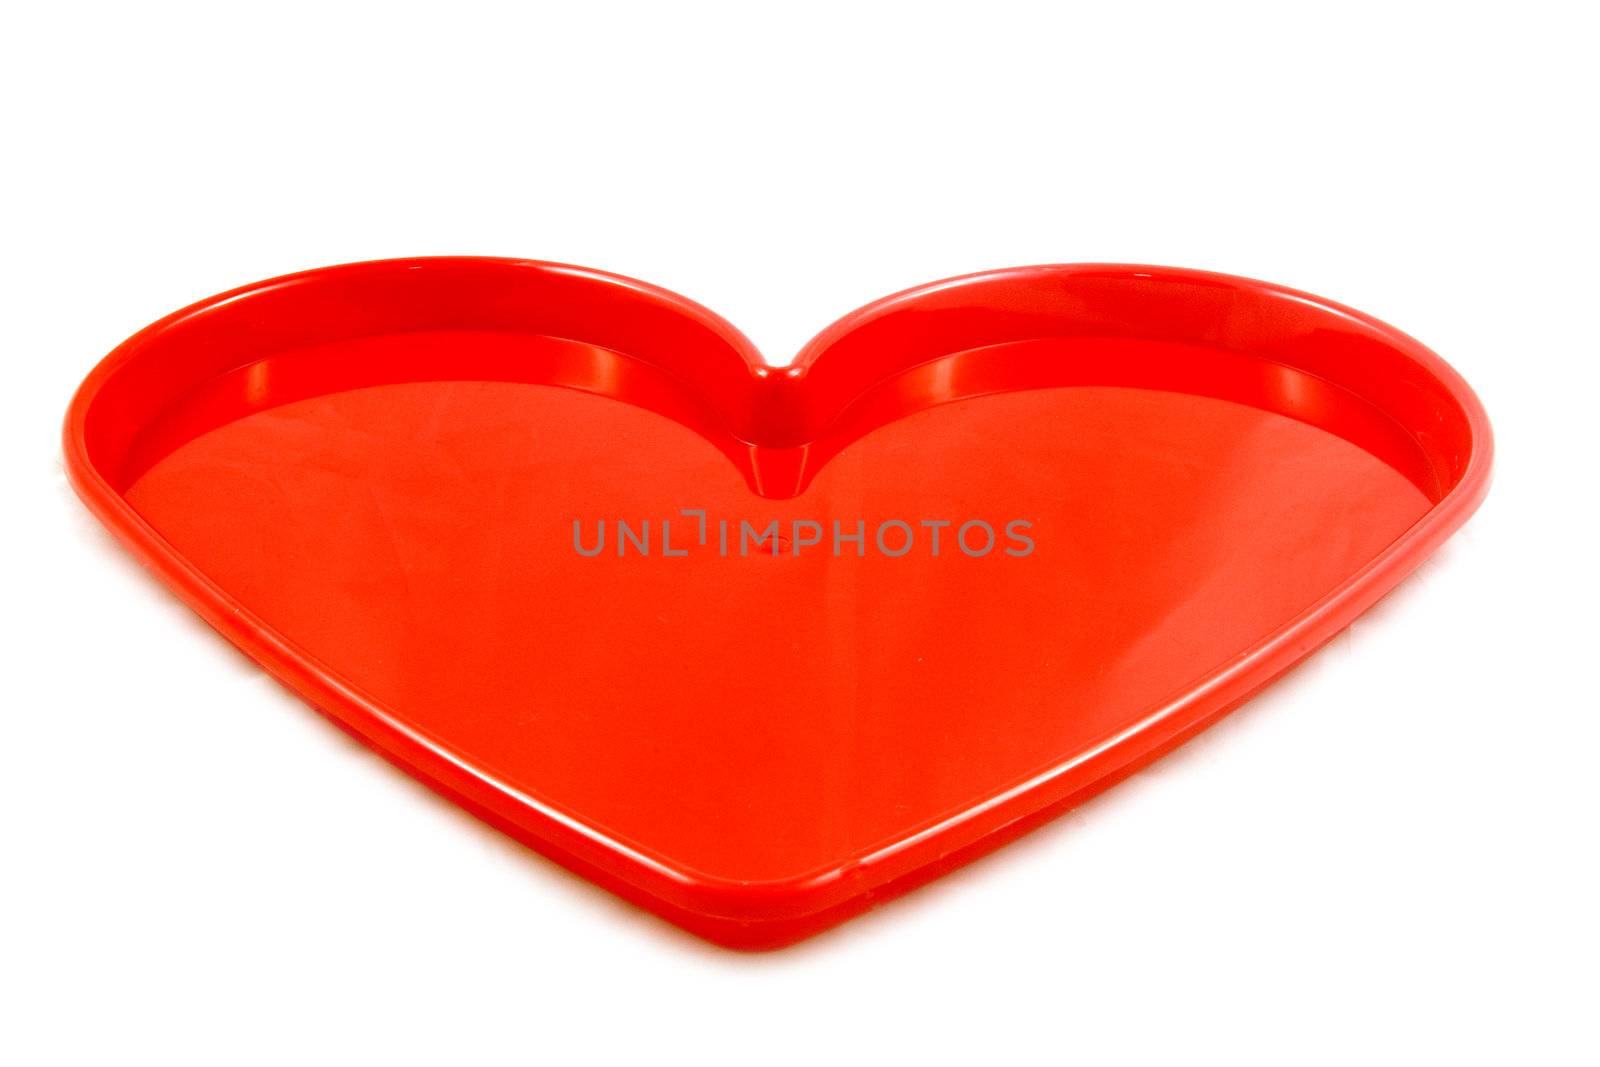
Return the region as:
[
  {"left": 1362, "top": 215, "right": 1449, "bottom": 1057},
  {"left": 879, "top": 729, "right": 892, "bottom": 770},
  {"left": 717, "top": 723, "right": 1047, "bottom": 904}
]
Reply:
[{"left": 66, "top": 258, "right": 1491, "bottom": 947}]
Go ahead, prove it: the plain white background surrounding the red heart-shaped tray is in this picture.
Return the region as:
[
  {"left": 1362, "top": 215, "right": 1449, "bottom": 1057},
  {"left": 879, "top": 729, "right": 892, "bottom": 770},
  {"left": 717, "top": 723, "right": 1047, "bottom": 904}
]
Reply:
[{"left": 0, "top": 2, "right": 1600, "bottom": 1065}]
